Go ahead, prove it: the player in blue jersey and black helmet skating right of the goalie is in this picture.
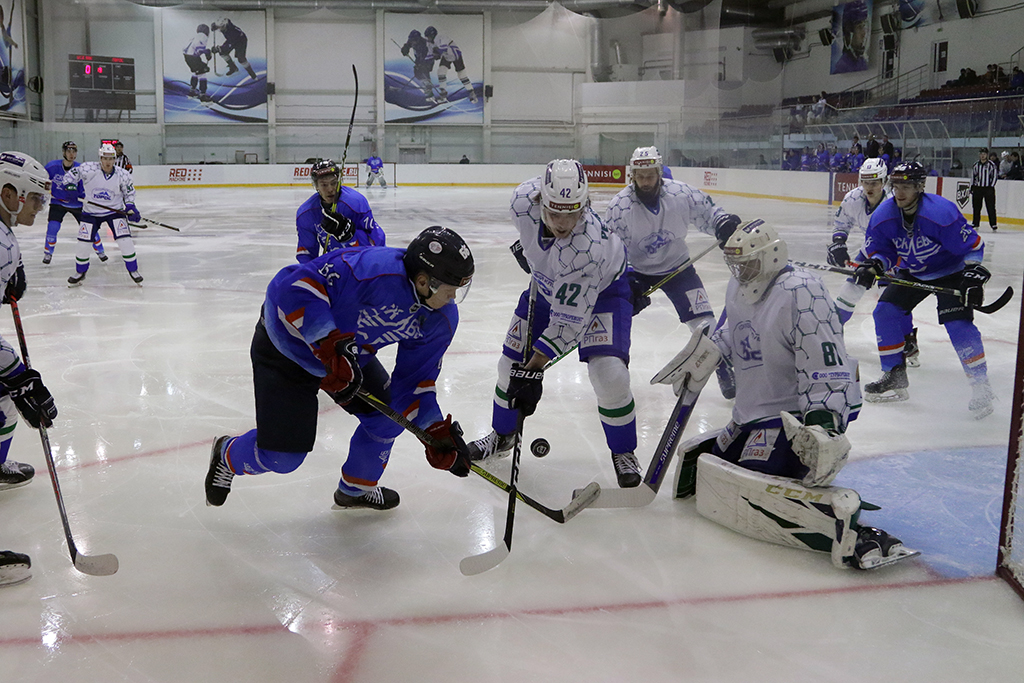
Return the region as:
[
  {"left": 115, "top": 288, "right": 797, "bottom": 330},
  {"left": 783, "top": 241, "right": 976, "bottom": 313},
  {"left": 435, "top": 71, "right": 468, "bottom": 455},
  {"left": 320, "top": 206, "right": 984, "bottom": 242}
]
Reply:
[{"left": 855, "top": 162, "right": 993, "bottom": 419}]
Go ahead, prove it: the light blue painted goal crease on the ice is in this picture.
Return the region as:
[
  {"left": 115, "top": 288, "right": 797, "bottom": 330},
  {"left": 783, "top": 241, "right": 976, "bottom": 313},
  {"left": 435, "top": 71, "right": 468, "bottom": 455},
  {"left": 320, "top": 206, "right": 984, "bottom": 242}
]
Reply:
[{"left": 834, "top": 446, "right": 1007, "bottom": 579}]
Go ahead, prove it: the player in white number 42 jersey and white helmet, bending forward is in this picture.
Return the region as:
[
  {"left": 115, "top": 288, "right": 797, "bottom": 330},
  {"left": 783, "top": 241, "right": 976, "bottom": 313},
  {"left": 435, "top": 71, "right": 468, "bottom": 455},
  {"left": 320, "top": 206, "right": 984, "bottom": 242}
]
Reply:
[{"left": 469, "top": 159, "right": 641, "bottom": 488}]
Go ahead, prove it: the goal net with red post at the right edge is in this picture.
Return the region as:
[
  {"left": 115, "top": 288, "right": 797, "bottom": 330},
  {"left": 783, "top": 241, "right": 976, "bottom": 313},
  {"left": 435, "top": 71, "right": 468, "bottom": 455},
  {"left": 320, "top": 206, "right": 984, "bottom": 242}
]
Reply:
[{"left": 995, "top": 272, "right": 1024, "bottom": 598}]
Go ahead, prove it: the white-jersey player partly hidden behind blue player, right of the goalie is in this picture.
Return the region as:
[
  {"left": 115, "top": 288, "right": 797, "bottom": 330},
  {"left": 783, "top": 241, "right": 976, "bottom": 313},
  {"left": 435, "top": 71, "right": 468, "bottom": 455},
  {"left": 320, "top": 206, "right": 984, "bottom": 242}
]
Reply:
[{"left": 826, "top": 159, "right": 921, "bottom": 368}]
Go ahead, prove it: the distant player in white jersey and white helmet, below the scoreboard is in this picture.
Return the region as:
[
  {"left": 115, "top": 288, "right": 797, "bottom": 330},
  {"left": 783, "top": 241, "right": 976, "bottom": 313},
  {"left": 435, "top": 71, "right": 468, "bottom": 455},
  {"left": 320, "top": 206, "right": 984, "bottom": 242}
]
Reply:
[{"left": 60, "top": 143, "right": 142, "bottom": 287}]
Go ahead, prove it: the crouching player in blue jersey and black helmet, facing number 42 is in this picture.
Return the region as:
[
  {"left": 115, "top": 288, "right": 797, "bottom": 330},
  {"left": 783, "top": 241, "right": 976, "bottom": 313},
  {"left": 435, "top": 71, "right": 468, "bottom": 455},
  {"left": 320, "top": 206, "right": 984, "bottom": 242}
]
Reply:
[{"left": 206, "top": 226, "right": 474, "bottom": 510}]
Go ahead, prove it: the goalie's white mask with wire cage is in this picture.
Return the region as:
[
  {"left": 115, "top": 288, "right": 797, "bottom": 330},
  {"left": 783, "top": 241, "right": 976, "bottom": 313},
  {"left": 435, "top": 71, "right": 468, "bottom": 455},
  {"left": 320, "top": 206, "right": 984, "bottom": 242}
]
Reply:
[{"left": 723, "top": 218, "right": 790, "bottom": 303}]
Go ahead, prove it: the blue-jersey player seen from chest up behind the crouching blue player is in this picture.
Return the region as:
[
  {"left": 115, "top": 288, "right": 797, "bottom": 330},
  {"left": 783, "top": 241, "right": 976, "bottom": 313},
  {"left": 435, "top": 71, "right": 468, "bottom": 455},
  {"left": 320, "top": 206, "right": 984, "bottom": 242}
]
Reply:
[{"left": 295, "top": 159, "right": 384, "bottom": 263}]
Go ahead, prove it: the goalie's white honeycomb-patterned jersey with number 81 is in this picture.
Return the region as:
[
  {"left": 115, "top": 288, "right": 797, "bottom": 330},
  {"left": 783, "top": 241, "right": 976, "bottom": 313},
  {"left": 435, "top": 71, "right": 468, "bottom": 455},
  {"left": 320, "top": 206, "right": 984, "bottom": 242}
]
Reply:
[{"left": 712, "top": 267, "right": 861, "bottom": 429}]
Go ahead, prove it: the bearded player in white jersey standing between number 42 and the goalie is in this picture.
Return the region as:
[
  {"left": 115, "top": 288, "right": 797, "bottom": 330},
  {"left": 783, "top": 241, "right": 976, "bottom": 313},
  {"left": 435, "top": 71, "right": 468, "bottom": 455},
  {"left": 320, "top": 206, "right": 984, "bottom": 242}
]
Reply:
[{"left": 604, "top": 147, "right": 739, "bottom": 398}]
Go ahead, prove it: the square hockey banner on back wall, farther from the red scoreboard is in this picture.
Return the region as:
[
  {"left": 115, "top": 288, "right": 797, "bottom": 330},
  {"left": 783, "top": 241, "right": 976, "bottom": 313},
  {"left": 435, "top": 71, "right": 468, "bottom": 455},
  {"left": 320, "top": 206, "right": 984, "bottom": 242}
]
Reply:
[{"left": 383, "top": 12, "right": 483, "bottom": 125}]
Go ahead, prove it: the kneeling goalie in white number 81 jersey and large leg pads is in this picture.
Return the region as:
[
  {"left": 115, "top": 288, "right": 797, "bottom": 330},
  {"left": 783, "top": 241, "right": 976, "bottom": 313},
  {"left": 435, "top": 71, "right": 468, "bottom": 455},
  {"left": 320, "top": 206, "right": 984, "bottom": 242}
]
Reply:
[{"left": 663, "top": 219, "right": 916, "bottom": 569}]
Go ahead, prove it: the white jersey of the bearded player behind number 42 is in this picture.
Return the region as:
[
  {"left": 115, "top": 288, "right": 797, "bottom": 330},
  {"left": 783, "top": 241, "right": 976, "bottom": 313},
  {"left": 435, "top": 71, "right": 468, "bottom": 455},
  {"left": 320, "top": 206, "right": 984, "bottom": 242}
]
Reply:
[{"left": 604, "top": 180, "right": 728, "bottom": 275}]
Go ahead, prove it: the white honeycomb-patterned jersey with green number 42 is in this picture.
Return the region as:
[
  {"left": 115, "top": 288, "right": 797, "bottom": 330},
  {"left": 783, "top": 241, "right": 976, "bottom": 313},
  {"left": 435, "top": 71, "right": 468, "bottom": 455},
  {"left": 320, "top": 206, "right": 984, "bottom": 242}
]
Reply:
[{"left": 509, "top": 176, "right": 626, "bottom": 357}]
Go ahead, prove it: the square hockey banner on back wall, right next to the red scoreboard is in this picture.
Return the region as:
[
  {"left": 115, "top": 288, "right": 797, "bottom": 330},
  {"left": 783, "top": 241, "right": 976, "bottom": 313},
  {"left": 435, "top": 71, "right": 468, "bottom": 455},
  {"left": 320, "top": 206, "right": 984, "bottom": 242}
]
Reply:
[{"left": 161, "top": 8, "right": 267, "bottom": 123}]
